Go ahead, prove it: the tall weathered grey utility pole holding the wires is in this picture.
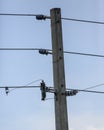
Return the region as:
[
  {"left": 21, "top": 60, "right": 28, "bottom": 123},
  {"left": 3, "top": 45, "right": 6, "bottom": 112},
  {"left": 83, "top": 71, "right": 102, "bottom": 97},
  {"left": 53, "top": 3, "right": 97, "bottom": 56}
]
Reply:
[{"left": 50, "top": 8, "right": 68, "bottom": 130}]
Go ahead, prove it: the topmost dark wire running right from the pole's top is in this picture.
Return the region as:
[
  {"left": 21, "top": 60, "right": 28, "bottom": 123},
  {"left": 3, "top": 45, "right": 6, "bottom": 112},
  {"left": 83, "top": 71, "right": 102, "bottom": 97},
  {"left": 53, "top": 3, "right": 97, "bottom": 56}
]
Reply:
[{"left": 62, "top": 18, "right": 104, "bottom": 25}]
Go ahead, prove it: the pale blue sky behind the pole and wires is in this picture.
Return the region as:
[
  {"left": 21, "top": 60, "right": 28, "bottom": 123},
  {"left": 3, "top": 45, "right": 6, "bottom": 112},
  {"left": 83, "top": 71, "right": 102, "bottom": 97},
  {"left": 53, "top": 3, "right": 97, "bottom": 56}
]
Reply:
[{"left": 0, "top": 0, "right": 104, "bottom": 130}]
